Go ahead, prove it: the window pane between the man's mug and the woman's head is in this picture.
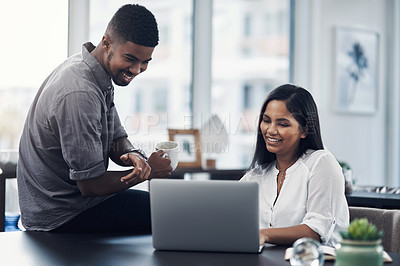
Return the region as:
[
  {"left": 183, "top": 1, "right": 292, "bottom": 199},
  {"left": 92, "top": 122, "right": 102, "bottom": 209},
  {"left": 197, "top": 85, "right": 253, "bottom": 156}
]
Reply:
[{"left": 211, "top": 0, "right": 290, "bottom": 168}]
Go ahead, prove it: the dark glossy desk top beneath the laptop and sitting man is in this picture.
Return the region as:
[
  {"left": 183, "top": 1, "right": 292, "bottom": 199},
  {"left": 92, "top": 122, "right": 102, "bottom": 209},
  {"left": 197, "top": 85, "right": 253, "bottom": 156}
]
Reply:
[{"left": 0, "top": 232, "right": 400, "bottom": 266}]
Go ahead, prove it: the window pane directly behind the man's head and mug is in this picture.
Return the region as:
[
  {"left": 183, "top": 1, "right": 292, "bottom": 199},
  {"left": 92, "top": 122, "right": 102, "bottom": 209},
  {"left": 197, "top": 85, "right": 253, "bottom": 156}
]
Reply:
[{"left": 89, "top": 0, "right": 193, "bottom": 152}]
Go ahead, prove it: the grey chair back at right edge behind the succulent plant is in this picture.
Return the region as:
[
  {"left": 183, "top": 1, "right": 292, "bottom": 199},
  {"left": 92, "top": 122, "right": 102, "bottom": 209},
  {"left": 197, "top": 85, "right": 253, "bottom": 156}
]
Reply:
[{"left": 349, "top": 206, "right": 400, "bottom": 253}]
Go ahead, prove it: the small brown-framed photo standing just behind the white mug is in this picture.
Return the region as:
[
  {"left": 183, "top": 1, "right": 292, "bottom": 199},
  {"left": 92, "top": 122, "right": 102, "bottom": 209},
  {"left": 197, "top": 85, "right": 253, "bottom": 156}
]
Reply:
[{"left": 168, "top": 129, "right": 201, "bottom": 168}]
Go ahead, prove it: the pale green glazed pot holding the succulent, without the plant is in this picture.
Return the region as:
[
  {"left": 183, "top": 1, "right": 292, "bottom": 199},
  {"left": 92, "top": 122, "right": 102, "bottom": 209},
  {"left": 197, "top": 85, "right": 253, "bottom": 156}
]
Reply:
[{"left": 335, "top": 239, "right": 383, "bottom": 266}]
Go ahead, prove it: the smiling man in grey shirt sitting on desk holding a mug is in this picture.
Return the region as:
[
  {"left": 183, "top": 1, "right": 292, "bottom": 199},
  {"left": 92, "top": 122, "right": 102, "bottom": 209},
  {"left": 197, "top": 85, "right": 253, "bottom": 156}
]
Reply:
[{"left": 17, "top": 5, "right": 172, "bottom": 233}]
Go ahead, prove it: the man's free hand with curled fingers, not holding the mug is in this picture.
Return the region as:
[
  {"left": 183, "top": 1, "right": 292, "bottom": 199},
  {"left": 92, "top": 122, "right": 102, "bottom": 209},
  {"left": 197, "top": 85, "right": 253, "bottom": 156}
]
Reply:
[{"left": 120, "top": 152, "right": 151, "bottom": 185}]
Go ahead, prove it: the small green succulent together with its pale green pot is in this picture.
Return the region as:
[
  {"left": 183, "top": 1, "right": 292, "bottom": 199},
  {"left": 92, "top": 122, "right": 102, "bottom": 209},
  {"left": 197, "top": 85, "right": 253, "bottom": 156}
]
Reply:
[{"left": 335, "top": 218, "right": 383, "bottom": 266}]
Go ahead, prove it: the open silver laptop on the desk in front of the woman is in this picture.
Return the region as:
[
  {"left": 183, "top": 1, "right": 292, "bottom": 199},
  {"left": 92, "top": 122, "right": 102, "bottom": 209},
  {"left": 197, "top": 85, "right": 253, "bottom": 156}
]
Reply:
[{"left": 150, "top": 179, "right": 263, "bottom": 253}]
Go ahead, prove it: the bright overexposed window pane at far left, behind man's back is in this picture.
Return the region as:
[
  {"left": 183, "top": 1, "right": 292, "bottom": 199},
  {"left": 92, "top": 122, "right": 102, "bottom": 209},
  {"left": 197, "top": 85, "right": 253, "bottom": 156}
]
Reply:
[{"left": 0, "top": 0, "right": 68, "bottom": 149}]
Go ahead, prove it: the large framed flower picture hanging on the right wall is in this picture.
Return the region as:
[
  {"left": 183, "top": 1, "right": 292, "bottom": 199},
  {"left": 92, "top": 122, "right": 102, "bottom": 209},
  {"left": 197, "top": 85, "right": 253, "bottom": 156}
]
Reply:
[{"left": 334, "top": 27, "right": 379, "bottom": 114}]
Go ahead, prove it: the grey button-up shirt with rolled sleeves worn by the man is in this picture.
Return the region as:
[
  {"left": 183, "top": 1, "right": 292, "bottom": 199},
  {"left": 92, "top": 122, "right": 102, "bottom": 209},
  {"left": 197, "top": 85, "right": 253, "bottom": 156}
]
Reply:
[{"left": 17, "top": 43, "right": 127, "bottom": 231}]
